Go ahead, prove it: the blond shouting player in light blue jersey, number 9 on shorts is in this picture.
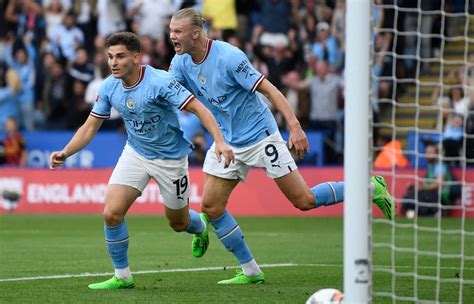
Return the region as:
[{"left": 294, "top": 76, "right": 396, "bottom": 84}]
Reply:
[{"left": 170, "top": 8, "right": 395, "bottom": 284}]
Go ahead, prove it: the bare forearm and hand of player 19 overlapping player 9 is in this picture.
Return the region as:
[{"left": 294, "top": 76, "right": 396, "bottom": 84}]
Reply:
[{"left": 185, "top": 98, "right": 234, "bottom": 168}]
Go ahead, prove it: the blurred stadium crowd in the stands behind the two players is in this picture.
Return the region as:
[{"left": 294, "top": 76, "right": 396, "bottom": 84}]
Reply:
[{"left": 0, "top": 0, "right": 472, "bottom": 164}]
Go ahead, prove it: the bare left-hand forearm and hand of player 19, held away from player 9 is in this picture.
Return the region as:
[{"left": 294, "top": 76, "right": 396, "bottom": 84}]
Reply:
[{"left": 49, "top": 115, "right": 103, "bottom": 169}]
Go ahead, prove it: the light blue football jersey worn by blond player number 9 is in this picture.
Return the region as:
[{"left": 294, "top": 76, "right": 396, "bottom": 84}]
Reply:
[{"left": 170, "top": 40, "right": 277, "bottom": 147}]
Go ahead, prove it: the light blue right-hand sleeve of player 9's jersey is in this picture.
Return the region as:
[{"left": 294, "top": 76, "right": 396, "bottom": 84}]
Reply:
[{"left": 227, "top": 49, "right": 265, "bottom": 93}]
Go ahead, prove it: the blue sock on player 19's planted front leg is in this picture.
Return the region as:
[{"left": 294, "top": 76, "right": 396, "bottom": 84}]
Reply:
[{"left": 104, "top": 220, "right": 128, "bottom": 269}]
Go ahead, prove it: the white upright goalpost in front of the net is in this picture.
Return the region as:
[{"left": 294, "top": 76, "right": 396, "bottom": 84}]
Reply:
[{"left": 344, "top": 0, "right": 371, "bottom": 303}]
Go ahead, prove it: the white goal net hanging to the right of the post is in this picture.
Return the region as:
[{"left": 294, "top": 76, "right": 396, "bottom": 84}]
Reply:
[{"left": 371, "top": 0, "right": 474, "bottom": 303}]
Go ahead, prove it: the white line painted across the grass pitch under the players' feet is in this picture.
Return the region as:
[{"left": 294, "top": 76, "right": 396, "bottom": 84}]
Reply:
[{"left": 0, "top": 263, "right": 474, "bottom": 283}]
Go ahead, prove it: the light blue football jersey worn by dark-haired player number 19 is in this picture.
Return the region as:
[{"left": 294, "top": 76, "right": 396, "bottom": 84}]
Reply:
[{"left": 91, "top": 65, "right": 194, "bottom": 159}]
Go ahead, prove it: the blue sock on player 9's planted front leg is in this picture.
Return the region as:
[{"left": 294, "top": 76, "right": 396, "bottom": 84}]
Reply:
[{"left": 211, "top": 210, "right": 253, "bottom": 264}]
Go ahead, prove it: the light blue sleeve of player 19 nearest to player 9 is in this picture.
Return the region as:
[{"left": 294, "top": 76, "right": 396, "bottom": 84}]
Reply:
[{"left": 160, "top": 72, "right": 194, "bottom": 110}]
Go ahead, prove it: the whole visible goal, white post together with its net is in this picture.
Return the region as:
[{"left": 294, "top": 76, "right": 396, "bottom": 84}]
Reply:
[{"left": 344, "top": 0, "right": 474, "bottom": 303}]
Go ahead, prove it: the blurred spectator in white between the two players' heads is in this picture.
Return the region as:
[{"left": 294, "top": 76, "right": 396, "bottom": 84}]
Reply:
[{"left": 126, "top": 0, "right": 174, "bottom": 41}]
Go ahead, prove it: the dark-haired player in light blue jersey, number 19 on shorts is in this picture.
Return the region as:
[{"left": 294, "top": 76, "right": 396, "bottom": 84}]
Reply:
[{"left": 50, "top": 32, "right": 233, "bottom": 289}]
